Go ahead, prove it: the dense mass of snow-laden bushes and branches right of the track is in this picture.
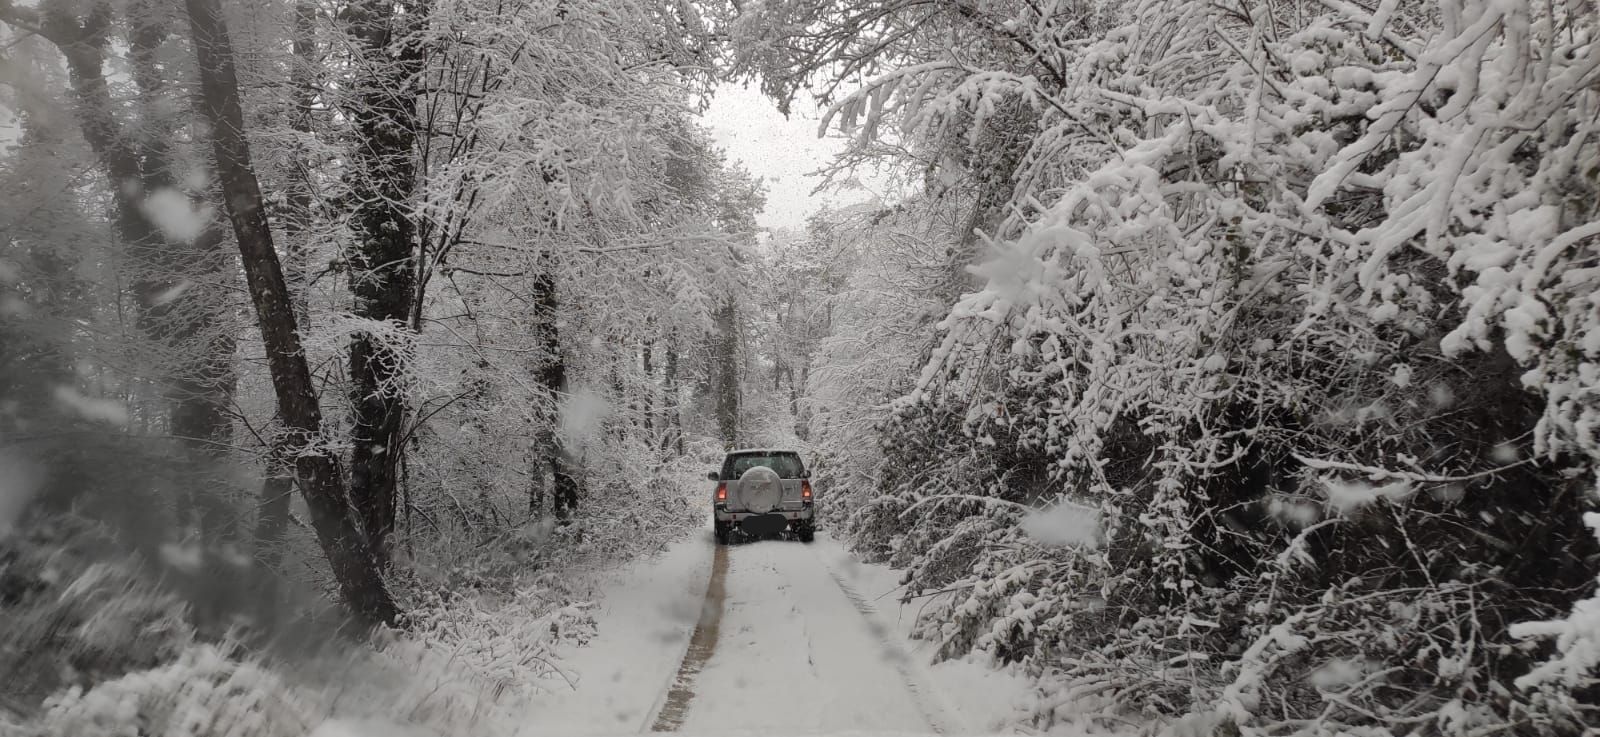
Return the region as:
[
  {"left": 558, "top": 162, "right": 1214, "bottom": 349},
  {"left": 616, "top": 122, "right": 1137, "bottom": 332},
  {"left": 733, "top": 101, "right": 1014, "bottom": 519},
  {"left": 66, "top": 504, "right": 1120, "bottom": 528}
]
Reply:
[{"left": 793, "top": 0, "right": 1600, "bottom": 735}]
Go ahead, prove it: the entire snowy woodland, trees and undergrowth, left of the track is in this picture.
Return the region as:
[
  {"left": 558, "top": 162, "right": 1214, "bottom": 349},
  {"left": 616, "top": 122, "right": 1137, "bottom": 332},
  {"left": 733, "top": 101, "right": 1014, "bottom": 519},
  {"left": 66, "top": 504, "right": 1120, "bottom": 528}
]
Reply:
[{"left": 0, "top": 0, "right": 792, "bottom": 725}]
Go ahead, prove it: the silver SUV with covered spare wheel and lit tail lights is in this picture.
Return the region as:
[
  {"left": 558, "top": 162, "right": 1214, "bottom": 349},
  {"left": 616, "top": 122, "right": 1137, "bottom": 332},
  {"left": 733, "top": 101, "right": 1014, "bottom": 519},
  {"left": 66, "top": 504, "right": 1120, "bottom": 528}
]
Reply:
[{"left": 706, "top": 448, "right": 816, "bottom": 545}]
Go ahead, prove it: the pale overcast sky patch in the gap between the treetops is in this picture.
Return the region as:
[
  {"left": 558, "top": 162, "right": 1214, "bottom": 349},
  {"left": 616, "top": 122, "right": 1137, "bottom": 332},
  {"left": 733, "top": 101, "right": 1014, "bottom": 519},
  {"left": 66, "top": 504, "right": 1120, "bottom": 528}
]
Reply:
[{"left": 702, "top": 85, "right": 869, "bottom": 229}]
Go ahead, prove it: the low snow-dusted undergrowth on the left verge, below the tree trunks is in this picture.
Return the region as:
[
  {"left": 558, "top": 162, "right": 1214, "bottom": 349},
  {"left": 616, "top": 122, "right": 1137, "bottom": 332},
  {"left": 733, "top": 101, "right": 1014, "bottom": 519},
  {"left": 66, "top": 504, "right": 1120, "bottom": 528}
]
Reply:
[{"left": 0, "top": 449, "right": 702, "bottom": 737}]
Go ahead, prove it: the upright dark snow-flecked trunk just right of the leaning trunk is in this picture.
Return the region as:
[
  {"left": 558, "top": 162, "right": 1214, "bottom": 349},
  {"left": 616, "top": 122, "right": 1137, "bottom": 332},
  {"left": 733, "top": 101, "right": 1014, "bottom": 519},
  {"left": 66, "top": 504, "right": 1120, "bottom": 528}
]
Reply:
[{"left": 347, "top": 0, "right": 426, "bottom": 566}]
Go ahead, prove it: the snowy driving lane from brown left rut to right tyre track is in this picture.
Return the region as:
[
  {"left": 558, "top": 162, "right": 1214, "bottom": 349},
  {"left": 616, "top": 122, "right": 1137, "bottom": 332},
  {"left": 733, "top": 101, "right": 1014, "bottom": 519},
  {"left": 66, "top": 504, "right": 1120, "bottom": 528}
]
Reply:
[{"left": 653, "top": 540, "right": 950, "bottom": 734}]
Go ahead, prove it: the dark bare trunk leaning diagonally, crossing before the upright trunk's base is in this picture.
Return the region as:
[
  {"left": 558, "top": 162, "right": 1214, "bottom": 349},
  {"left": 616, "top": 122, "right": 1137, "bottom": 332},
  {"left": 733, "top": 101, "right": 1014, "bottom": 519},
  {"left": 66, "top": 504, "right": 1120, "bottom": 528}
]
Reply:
[{"left": 184, "top": 0, "right": 400, "bottom": 625}]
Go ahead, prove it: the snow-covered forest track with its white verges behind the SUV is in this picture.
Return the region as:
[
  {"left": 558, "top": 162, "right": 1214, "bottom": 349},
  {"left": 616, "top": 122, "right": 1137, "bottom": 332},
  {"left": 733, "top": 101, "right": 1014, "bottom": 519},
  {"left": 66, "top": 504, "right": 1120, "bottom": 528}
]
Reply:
[{"left": 523, "top": 531, "right": 1027, "bottom": 735}]
